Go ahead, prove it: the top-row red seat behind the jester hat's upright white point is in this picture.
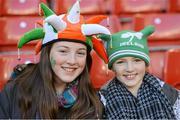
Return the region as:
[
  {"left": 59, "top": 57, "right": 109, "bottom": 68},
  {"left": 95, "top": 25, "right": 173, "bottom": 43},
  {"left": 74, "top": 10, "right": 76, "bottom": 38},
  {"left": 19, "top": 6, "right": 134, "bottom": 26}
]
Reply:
[{"left": 50, "top": 0, "right": 107, "bottom": 14}]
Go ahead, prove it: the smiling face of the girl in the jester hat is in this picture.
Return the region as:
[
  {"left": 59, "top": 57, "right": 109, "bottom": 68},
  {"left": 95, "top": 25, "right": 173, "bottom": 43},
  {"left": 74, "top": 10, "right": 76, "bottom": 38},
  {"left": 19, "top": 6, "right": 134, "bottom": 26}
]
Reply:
[{"left": 50, "top": 41, "right": 87, "bottom": 83}]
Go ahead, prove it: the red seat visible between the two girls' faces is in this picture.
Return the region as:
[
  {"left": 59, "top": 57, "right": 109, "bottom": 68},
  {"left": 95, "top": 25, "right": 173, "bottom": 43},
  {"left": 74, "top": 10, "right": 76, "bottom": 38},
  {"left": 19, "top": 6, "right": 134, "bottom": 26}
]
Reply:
[{"left": 90, "top": 51, "right": 114, "bottom": 89}]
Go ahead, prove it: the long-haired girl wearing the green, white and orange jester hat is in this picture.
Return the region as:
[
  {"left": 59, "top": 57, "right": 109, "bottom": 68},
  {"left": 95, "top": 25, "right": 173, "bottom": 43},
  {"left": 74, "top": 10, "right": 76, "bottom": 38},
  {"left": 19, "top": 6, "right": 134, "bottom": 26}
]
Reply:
[{"left": 0, "top": 1, "right": 110, "bottom": 119}]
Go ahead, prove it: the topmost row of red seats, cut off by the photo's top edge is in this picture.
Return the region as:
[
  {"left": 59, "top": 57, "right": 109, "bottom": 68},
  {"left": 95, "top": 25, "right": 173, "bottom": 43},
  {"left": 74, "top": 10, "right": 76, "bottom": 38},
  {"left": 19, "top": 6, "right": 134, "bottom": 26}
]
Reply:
[{"left": 0, "top": 0, "right": 180, "bottom": 16}]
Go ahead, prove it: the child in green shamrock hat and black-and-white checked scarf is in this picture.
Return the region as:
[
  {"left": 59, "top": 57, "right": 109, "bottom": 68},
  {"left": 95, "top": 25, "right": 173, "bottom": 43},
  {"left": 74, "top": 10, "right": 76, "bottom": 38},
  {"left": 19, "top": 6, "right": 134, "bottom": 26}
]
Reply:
[{"left": 99, "top": 26, "right": 180, "bottom": 119}]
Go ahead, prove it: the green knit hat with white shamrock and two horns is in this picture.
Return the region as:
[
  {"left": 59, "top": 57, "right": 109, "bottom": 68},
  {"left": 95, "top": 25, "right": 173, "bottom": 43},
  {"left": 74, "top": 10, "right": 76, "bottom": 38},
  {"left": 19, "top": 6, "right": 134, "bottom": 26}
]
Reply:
[{"left": 99, "top": 26, "right": 154, "bottom": 69}]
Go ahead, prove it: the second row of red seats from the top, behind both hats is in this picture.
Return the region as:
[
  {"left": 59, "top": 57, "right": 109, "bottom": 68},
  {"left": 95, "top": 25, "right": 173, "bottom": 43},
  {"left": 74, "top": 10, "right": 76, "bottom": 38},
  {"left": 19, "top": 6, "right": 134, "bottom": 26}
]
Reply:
[{"left": 0, "top": 13, "right": 180, "bottom": 46}]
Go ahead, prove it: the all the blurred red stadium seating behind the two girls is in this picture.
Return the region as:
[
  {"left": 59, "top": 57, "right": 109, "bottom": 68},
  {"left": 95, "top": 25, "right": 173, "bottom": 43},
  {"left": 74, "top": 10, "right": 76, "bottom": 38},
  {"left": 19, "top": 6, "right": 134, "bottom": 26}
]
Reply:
[{"left": 0, "top": 0, "right": 180, "bottom": 90}]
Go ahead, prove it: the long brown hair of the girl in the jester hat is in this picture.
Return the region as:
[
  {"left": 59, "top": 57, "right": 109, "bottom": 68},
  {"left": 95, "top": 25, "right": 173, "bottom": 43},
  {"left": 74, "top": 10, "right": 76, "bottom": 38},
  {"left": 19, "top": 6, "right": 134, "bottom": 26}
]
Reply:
[{"left": 16, "top": 41, "right": 102, "bottom": 119}]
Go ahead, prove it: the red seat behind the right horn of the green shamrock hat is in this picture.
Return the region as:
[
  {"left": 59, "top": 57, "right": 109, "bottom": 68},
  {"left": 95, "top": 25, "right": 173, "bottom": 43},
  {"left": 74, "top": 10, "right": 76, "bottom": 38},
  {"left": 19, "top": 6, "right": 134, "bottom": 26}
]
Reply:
[{"left": 134, "top": 13, "right": 180, "bottom": 46}]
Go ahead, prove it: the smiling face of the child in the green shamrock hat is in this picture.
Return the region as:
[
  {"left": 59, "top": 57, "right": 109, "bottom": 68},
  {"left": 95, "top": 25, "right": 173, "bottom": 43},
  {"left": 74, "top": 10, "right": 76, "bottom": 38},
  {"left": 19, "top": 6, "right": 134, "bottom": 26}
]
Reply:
[{"left": 113, "top": 57, "right": 146, "bottom": 91}]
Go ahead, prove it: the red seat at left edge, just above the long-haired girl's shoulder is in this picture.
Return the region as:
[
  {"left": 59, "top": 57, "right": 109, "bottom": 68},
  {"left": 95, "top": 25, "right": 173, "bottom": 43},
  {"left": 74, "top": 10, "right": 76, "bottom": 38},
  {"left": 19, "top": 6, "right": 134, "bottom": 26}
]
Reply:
[{"left": 0, "top": 51, "right": 38, "bottom": 90}]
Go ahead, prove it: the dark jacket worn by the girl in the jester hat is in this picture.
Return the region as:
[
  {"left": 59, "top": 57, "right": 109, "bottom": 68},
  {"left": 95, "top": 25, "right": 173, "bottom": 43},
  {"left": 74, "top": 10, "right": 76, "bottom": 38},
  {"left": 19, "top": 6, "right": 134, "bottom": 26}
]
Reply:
[{"left": 0, "top": 80, "right": 69, "bottom": 119}]
